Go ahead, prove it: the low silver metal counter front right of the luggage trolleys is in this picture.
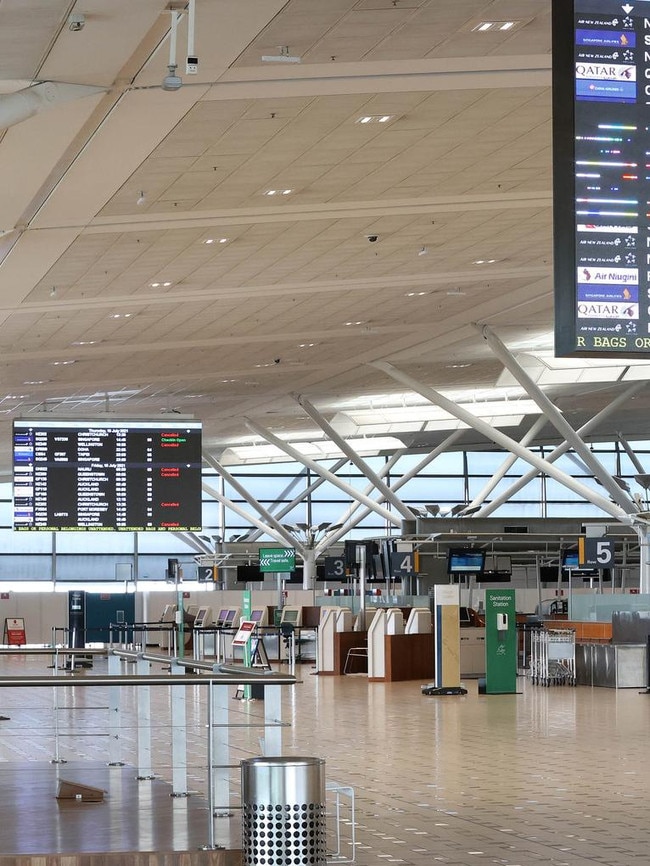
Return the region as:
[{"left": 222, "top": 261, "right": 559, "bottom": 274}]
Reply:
[{"left": 576, "top": 643, "right": 647, "bottom": 689}]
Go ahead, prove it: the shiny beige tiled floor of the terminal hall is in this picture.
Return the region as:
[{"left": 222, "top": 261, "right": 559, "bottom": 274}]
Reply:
[{"left": 0, "top": 656, "right": 650, "bottom": 866}]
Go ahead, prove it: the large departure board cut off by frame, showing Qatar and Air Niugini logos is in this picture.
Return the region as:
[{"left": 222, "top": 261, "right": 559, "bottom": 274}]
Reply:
[{"left": 553, "top": 0, "right": 650, "bottom": 357}]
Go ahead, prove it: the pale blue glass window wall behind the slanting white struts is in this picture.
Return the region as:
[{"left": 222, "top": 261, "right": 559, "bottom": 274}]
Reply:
[{"left": 0, "top": 442, "right": 650, "bottom": 585}]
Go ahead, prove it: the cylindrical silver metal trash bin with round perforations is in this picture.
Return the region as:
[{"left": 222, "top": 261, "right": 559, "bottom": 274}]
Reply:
[{"left": 241, "top": 758, "right": 327, "bottom": 866}]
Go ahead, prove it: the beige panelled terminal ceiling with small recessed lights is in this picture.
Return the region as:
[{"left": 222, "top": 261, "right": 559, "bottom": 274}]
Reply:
[{"left": 0, "top": 0, "right": 648, "bottom": 470}]
